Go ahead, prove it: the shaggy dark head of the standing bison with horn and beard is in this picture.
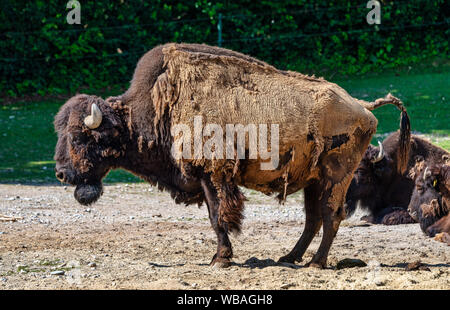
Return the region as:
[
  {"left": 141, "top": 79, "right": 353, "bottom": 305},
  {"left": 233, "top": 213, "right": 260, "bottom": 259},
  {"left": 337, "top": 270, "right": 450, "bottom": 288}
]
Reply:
[{"left": 54, "top": 95, "right": 127, "bottom": 205}]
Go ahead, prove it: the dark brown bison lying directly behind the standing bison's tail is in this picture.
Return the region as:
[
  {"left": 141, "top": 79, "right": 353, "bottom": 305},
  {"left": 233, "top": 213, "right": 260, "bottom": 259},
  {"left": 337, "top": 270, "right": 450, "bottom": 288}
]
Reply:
[{"left": 346, "top": 126, "right": 448, "bottom": 225}]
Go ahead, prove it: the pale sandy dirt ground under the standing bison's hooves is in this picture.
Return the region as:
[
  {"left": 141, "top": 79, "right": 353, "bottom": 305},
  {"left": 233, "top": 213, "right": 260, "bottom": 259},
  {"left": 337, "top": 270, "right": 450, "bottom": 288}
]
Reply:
[{"left": 0, "top": 184, "right": 450, "bottom": 290}]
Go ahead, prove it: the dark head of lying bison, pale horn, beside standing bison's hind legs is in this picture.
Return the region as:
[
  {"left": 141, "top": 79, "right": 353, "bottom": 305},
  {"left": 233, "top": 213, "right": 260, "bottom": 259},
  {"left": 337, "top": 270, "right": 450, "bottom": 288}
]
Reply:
[{"left": 346, "top": 142, "right": 396, "bottom": 216}]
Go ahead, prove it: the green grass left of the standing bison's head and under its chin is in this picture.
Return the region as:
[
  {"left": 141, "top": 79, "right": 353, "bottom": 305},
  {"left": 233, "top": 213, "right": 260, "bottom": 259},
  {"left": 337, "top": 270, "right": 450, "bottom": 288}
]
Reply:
[{"left": 0, "top": 101, "right": 139, "bottom": 184}]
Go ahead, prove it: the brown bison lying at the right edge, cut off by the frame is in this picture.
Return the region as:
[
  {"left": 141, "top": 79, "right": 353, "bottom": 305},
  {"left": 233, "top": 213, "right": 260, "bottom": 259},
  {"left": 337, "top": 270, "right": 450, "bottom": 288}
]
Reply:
[{"left": 408, "top": 158, "right": 450, "bottom": 244}]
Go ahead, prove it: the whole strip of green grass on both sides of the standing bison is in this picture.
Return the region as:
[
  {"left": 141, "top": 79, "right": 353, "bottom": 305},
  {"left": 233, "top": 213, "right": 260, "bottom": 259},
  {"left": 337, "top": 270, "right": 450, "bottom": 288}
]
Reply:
[{"left": 0, "top": 72, "right": 450, "bottom": 184}]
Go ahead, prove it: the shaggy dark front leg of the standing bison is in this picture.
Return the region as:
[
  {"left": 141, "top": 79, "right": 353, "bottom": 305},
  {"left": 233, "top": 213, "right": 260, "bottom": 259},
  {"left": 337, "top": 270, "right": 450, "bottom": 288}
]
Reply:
[{"left": 201, "top": 176, "right": 244, "bottom": 268}]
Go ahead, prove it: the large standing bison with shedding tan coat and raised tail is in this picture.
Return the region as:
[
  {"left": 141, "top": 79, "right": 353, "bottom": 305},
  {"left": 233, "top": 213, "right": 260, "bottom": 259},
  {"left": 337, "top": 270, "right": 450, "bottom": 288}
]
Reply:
[{"left": 55, "top": 44, "right": 402, "bottom": 267}]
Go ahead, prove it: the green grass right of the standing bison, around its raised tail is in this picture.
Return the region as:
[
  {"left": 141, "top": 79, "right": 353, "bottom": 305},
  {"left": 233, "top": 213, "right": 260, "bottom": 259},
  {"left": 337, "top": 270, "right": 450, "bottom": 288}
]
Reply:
[{"left": 335, "top": 72, "right": 450, "bottom": 137}]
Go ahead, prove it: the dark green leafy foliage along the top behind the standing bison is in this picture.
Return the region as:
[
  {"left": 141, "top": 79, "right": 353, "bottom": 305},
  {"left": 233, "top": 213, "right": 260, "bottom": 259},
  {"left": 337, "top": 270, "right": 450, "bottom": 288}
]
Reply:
[{"left": 0, "top": 0, "right": 450, "bottom": 98}]
